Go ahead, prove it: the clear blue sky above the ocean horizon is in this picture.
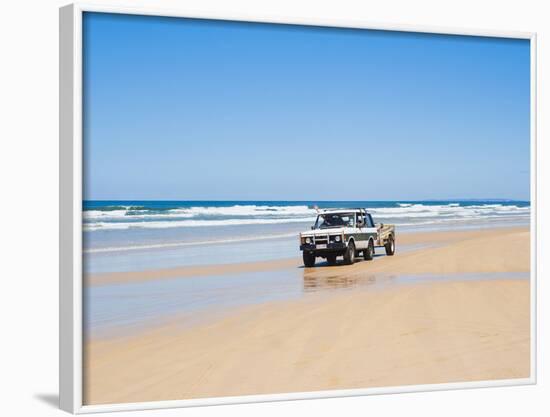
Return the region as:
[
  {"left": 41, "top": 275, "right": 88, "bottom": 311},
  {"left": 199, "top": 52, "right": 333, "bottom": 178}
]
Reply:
[{"left": 84, "top": 13, "right": 530, "bottom": 200}]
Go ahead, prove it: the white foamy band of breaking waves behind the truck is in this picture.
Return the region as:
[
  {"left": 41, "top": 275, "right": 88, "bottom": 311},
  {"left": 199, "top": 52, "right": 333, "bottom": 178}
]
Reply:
[{"left": 83, "top": 203, "right": 530, "bottom": 231}]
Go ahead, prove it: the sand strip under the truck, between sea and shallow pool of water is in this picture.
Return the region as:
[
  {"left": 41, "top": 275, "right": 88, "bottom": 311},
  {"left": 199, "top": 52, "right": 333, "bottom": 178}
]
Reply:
[{"left": 84, "top": 227, "right": 529, "bottom": 285}]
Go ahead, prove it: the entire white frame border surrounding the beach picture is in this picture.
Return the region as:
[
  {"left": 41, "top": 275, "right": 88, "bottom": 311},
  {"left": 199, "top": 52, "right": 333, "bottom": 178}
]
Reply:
[{"left": 59, "top": 3, "right": 537, "bottom": 414}]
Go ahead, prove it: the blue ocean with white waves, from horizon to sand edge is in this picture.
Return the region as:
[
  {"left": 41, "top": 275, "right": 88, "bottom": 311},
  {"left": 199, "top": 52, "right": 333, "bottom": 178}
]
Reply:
[{"left": 82, "top": 200, "right": 531, "bottom": 273}]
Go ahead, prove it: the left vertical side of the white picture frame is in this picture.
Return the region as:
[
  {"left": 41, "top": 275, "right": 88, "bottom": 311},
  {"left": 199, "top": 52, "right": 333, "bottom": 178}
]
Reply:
[{"left": 59, "top": 5, "right": 82, "bottom": 413}]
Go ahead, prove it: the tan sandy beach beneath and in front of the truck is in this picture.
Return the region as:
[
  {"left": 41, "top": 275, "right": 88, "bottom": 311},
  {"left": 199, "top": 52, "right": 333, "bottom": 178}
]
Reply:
[{"left": 84, "top": 227, "right": 530, "bottom": 404}]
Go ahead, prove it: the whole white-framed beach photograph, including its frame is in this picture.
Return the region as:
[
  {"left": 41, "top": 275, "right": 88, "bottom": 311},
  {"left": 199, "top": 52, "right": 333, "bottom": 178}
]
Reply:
[{"left": 60, "top": 5, "right": 536, "bottom": 413}]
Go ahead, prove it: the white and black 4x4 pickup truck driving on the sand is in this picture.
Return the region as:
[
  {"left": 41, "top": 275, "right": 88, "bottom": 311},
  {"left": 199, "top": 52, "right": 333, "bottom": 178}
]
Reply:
[{"left": 300, "top": 208, "right": 395, "bottom": 267}]
